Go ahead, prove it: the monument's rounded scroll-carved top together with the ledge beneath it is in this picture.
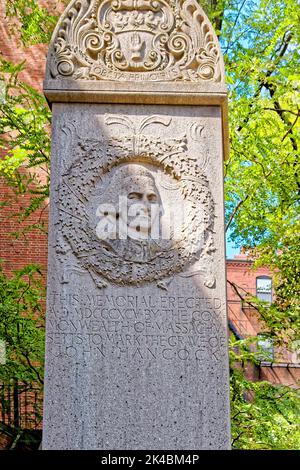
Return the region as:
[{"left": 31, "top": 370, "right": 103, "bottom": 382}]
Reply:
[{"left": 44, "top": 0, "right": 226, "bottom": 109}]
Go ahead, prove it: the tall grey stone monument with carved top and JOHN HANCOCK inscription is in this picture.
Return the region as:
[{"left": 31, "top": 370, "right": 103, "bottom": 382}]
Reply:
[{"left": 43, "top": 0, "right": 230, "bottom": 450}]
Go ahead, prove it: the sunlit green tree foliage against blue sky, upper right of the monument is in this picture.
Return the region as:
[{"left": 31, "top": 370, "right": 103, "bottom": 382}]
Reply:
[{"left": 221, "top": 0, "right": 300, "bottom": 345}]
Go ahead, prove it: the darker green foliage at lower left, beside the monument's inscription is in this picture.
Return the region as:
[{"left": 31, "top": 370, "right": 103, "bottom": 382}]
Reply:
[{"left": 0, "top": 265, "right": 44, "bottom": 448}]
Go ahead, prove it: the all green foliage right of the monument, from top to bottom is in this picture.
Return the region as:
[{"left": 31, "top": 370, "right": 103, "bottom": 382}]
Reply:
[{"left": 200, "top": 0, "right": 300, "bottom": 450}]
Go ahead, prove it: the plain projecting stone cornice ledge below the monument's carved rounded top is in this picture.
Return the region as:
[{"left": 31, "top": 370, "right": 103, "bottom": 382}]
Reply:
[{"left": 44, "top": 79, "right": 229, "bottom": 160}]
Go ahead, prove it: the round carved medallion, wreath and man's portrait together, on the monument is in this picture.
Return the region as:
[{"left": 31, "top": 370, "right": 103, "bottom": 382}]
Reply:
[{"left": 57, "top": 115, "right": 214, "bottom": 287}]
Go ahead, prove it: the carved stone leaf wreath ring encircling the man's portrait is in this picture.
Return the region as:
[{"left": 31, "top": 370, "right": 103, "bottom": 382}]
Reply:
[{"left": 56, "top": 115, "right": 215, "bottom": 287}]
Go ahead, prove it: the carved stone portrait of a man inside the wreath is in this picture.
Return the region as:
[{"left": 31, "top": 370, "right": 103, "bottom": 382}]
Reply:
[{"left": 91, "top": 163, "right": 170, "bottom": 263}]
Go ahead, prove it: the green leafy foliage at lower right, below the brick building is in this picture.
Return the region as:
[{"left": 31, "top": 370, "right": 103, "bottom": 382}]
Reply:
[{"left": 230, "top": 338, "right": 300, "bottom": 450}]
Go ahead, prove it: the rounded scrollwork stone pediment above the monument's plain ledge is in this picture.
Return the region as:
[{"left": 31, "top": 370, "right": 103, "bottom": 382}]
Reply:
[{"left": 48, "top": 0, "right": 224, "bottom": 83}]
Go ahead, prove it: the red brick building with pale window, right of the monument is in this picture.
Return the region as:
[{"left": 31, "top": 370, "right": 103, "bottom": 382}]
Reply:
[{"left": 226, "top": 255, "right": 300, "bottom": 387}]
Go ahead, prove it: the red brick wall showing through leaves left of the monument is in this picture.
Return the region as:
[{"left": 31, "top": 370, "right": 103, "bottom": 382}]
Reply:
[{"left": 0, "top": 1, "right": 48, "bottom": 271}]
